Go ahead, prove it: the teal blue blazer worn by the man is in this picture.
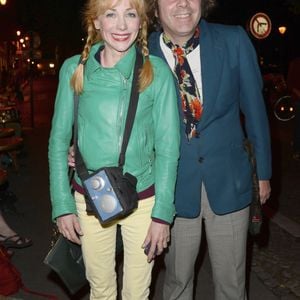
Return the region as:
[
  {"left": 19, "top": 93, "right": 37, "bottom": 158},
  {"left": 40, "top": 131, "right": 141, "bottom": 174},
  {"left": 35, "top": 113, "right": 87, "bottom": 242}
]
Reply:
[{"left": 149, "top": 20, "right": 271, "bottom": 218}]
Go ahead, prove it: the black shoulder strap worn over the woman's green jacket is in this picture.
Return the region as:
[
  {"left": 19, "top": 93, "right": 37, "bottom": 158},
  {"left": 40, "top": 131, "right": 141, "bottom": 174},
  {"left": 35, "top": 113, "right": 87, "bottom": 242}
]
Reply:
[{"left": 74, "top": 49, "right": 143, "bottom": 178}]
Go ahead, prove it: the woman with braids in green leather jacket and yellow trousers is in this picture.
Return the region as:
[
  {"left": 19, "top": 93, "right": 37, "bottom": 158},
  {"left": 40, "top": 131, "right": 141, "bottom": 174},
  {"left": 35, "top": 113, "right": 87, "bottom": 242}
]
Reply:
[{"left": 49, "top": 0, "right": 179, "bottom": 300}]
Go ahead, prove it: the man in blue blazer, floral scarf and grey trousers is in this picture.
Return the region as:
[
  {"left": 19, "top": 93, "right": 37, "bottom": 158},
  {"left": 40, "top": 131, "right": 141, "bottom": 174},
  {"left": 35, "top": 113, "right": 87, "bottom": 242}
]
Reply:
[{"left": 149, "top": 0, "right": 271, "bottom": 300}]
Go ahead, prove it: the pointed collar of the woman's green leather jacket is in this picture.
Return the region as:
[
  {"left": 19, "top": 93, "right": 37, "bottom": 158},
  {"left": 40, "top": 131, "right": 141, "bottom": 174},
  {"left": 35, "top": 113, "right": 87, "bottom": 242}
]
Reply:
[{"left": 85, "top": 43, "right": 136, "bottom": 79}]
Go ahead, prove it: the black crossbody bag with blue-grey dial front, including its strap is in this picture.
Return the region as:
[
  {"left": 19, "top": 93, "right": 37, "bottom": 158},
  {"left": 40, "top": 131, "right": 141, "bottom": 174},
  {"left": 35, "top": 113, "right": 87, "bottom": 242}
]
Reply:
[{"left": 74, "top": 51, "right": 143, "bottom": 224}]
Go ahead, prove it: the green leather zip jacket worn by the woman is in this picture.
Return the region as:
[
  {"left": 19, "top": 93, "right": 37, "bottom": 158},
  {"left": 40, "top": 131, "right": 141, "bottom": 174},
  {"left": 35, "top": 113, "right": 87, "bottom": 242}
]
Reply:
[{"left": 49, "top": 44, "right": 180, "bottom": 223}]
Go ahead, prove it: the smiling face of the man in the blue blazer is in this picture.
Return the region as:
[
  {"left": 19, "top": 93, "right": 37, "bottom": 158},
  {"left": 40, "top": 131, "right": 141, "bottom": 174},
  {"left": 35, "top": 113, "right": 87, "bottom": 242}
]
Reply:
[{"left": 158, "top": 0, "right": 201, "bottom": 45}]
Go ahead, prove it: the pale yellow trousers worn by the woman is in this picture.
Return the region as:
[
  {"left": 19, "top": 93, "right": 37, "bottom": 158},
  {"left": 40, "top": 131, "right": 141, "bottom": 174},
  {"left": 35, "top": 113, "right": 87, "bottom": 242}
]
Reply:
[{"left": 75, "top": 192, "right": 154, "bottom": 300}]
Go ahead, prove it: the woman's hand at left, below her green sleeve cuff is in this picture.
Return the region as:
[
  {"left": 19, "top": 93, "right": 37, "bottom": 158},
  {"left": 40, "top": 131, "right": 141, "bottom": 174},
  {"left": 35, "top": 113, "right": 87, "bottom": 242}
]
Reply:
[{"left": 56, "top": 214, "right": 82, "bottom": 245}]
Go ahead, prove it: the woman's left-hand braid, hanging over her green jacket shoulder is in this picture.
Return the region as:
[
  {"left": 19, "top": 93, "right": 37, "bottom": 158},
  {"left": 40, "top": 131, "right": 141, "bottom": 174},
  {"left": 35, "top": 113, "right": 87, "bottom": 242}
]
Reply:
[{"left": 71, "top": 24, "right": 97, "bottom": 94}]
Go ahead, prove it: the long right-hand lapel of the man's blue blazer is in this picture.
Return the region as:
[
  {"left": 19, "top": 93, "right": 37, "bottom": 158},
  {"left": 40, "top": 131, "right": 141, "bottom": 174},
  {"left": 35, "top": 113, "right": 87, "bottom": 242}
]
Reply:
[{"left": 198, "top": 20, "right": 224, "bottom": 130}]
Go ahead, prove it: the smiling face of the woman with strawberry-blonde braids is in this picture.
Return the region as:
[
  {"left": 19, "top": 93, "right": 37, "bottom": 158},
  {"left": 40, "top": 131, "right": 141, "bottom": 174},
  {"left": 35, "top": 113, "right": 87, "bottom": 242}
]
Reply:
[{"left": 94, "top": 0, "right": 140, "bottom": 58}]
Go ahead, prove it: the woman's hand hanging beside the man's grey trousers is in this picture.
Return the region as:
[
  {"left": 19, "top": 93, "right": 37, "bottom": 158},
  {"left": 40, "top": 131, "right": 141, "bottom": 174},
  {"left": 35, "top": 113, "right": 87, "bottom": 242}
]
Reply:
[{"left": 142, "top": 221, "right": 170, "bottom": 262}]
